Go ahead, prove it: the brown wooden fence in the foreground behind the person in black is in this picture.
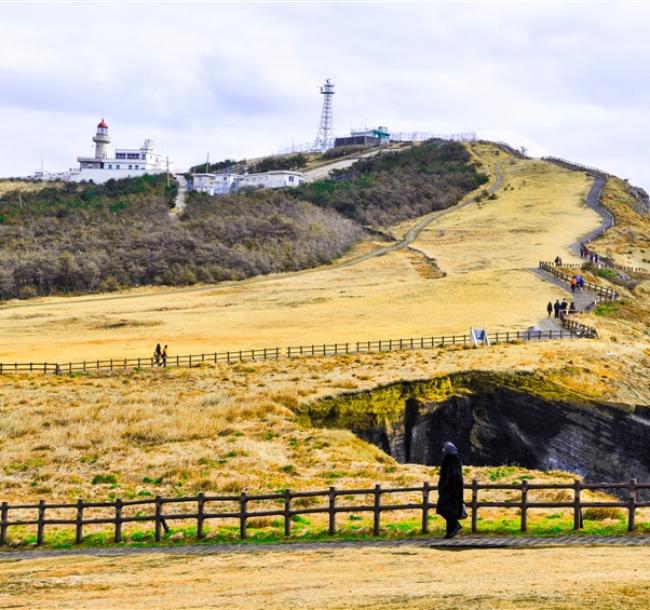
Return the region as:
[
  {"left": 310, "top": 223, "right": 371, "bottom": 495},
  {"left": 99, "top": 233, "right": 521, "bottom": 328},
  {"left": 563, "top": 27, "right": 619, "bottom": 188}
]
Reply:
[{"left": 0, "top": 479, "right": 650, "bottom": 545}]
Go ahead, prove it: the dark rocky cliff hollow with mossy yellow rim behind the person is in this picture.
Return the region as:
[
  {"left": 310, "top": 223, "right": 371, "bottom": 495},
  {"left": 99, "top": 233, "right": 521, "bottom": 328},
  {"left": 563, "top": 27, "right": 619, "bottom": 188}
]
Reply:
[{"left": 303, "top": 372, "right": 650, "bottom": 481}]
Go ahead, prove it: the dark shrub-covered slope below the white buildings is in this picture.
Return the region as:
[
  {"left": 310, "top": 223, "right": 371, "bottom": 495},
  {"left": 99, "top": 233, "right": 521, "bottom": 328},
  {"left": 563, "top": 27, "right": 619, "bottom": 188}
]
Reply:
[{"left": 0, "top": 142, "right": 484, "bottom": 299}]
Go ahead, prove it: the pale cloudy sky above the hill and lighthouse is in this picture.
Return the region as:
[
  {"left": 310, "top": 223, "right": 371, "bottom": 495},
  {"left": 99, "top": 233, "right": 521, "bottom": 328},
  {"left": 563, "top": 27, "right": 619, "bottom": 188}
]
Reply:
[{"left": 0, "top": 0, "right": 650, "bottom": 190}]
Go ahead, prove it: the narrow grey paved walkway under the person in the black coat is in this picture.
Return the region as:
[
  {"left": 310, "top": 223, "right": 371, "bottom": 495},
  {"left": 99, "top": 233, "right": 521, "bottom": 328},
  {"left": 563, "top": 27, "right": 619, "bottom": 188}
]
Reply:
[{"left": 0, "top": 535, "right": 650, "bottom": 561}]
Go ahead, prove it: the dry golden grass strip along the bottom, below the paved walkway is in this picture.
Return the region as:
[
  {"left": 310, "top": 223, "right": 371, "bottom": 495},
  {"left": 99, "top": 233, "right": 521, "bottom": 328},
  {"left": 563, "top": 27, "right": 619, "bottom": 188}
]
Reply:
[{"left": 0, "top": 547, "right": 650, "bottom": 610}]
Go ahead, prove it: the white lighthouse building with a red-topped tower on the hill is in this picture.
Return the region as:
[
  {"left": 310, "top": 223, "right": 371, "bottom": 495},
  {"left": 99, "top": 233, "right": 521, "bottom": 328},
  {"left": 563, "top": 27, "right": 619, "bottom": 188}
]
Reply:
[{"left": 35, "top": 119, "right": 172, "bottom": 184}]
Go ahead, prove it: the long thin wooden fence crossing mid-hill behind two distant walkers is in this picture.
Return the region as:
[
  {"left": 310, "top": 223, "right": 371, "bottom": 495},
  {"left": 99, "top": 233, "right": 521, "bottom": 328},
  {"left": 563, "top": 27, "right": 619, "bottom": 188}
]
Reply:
[{"left": 0, "top": 328, "right": 581, "bottom": 374}]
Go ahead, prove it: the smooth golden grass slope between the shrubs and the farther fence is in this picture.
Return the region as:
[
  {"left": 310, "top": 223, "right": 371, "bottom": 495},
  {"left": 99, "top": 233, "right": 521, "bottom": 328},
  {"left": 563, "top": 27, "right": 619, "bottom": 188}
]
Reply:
[{"left": 0, "top": 144, "right": 598, "bottom": 362}]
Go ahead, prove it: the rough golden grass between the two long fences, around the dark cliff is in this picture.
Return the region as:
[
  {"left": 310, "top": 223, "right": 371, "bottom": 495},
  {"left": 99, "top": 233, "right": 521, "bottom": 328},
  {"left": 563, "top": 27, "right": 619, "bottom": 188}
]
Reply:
[{"left": 0, "top": 332, "right": 650, "bottom": 501}]
